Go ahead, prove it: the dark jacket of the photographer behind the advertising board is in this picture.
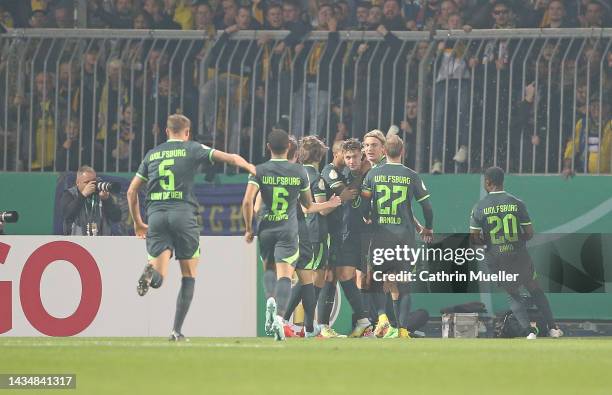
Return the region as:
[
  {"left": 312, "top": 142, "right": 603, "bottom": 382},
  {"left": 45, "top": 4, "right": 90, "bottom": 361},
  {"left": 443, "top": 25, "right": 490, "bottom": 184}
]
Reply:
[{"left": 60, "top": 186, "right": 121, "bottom": 236}]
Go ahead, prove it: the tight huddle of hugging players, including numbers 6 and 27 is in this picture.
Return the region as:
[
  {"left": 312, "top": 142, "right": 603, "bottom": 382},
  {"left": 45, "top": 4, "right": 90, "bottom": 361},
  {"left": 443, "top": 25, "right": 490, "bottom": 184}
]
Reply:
[{"left": 242, "top": 130, "right": 433, "bottom": 340}]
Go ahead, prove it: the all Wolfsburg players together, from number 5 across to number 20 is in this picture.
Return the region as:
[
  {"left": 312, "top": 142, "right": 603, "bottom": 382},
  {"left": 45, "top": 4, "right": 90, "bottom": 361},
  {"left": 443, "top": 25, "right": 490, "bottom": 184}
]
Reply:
[{"left": 128, "top": 114, "right": 562, "bottom": 341}]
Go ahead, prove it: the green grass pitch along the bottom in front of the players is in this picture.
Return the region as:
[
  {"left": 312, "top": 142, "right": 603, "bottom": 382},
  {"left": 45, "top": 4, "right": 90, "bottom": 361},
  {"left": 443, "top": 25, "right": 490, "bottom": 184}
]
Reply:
[{"left": 0, "top": 338, "right": 612, "bottom": 395}]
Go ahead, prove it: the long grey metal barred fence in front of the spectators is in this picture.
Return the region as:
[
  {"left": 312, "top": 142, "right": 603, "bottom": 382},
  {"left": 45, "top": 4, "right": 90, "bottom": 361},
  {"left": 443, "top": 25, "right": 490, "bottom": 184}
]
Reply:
[{"left": 0, "top": 29, "right": 612, "bottom": 173}]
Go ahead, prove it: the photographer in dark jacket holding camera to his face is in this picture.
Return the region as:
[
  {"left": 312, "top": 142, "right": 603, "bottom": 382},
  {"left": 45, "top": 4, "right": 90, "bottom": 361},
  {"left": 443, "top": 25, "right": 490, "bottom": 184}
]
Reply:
[{"left": 61, "top": 166, "right": 121, "bottom": 236}]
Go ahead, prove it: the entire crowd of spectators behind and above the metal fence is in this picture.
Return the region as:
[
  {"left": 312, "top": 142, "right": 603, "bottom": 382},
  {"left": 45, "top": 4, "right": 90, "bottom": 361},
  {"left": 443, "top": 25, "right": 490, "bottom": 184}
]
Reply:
[{"left": 0, "top": 0, "right": 612, "bottom": 174}]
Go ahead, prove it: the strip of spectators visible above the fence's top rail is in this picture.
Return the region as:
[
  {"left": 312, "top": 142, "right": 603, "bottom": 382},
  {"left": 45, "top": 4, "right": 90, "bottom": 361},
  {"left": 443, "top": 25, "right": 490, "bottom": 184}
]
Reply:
[{"left": 0, "top": 0, "right": 612, "bottom": 31}]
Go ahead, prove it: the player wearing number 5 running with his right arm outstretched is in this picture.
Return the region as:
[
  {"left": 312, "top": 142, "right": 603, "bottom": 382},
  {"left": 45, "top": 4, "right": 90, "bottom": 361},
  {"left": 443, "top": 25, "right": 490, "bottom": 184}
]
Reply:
[{"left": 127, "top": 114, "right": 255, "bottom": 341}]
